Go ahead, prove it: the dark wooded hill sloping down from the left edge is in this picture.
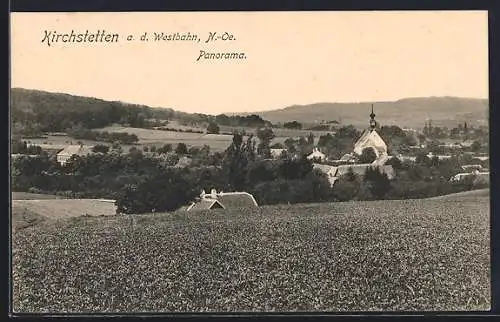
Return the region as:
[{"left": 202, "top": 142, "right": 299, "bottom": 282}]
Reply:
[{"left": 10, "top": 88, "right": 268, "bottom": 135}]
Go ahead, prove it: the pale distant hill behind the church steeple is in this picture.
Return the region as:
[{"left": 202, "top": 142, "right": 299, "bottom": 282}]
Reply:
[{"left": 250, "top": 97, "right": 489, "bottom": 128}]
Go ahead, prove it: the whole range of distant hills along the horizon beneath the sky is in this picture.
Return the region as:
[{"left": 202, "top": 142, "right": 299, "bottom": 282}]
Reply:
[{"left": 11, "top": 88, "right": 488, "bottom": 132}]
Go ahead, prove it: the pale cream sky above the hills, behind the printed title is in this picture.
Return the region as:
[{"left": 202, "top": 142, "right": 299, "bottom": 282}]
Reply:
[{"left": 11, "top": 11, "right": 488, "bottom": 114}]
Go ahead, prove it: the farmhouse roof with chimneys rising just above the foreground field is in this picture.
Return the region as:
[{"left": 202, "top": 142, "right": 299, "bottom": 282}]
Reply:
[{"left": 186, "top": 189, "right": 258, "bottom": 211}]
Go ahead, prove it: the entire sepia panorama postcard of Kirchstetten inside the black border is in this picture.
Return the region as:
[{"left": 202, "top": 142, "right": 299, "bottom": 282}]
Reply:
[{"left": 9, "top": 11, "right": 492, "bottom": 314}]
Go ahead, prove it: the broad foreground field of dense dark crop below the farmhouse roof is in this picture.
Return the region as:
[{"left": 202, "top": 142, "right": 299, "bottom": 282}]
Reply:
[{"left": 13, "top": 197, "right": 490, "bottom": 312}]
